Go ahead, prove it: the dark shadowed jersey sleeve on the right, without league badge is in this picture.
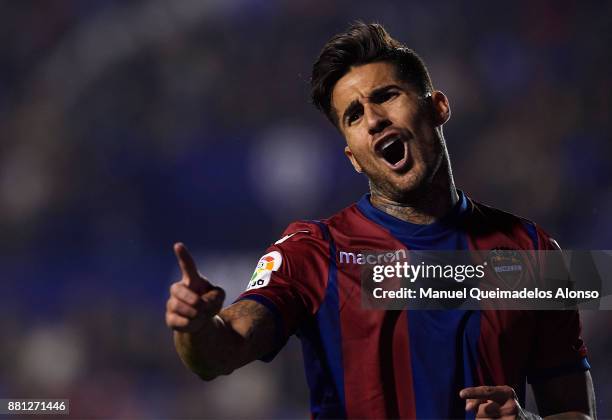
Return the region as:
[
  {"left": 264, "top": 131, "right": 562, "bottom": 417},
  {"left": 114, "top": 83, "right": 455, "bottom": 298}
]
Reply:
[{"left": 527, "top": 227, "right": 590, "bottom": 383}]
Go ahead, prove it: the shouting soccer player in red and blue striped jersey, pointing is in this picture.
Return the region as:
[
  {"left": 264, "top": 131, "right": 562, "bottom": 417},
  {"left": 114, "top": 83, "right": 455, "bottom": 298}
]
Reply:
[{"left": 166, "top": 23, "right": 595, "bottom": 419}]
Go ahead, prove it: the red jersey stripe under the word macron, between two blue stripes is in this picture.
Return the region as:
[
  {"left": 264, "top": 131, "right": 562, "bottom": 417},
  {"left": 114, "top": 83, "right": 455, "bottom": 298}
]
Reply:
[{"left": 330, "top": 207, "right": 415, "bottom": 418}]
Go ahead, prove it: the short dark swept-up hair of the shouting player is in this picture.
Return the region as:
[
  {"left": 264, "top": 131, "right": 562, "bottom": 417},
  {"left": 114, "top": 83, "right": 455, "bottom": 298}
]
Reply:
[{"left": 310, "top": 22, "right": 433, "bottom": 127}]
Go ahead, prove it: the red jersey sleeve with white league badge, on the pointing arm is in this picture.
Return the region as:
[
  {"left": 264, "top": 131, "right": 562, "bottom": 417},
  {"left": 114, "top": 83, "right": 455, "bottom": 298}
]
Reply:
[{"left": 237, "top": 222, "right": 329, "bottom": 361}]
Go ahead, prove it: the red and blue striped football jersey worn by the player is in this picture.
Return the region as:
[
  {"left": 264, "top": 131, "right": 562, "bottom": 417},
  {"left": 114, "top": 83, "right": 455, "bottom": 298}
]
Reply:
[{"left": 239, "top": 192, "right": 589, "bottom": 418}]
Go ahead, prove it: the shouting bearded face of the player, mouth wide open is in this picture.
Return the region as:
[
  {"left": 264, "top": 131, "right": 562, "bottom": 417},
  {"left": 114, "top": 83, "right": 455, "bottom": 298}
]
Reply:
[{"left": 332, "top": 62, "right": 450, "bottom": 201}]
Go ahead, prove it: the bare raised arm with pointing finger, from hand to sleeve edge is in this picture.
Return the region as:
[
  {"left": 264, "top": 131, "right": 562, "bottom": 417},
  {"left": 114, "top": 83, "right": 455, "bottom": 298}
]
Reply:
[{"left": 166, "top": 243, "right": 276, "bottom": 381}]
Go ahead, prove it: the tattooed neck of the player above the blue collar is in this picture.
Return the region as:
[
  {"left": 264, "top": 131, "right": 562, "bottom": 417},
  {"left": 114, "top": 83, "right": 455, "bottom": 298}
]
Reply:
[{"left": 370, "top": 163, "right": 459, "bottom": 225}]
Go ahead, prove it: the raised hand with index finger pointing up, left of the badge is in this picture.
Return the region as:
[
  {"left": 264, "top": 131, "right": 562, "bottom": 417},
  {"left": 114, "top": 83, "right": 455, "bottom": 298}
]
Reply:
[{"left": 166, "top": 243, "right": 225, "bottom": 333}]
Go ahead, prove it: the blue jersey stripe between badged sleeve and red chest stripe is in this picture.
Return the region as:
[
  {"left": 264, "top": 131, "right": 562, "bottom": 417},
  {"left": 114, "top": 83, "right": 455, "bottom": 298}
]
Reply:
[{"left": 298, "top": 221, "right": 346, "bottom": 418}]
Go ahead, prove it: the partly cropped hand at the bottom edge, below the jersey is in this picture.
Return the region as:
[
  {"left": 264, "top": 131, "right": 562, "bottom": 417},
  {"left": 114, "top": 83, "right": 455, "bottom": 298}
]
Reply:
[{"left": 459, "top": 385, "right": 526, "bottom": 420}]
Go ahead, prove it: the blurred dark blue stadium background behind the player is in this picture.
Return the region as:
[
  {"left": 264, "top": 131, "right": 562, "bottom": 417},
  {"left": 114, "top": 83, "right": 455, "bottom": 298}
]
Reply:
[{"left": 0, "top": 0, "right": 612, "bottom": 418}]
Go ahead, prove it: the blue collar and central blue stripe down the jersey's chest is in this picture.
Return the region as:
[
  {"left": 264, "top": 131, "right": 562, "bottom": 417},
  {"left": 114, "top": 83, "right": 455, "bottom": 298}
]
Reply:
[{"left": 358, "top": 192, "right": 480, "bottom": 418}]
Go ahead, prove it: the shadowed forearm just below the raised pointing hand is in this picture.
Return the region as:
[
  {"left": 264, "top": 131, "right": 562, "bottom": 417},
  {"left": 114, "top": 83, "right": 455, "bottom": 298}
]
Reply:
[{"left": 174, "top": 316, "right": 248, "bottom": 381}]
